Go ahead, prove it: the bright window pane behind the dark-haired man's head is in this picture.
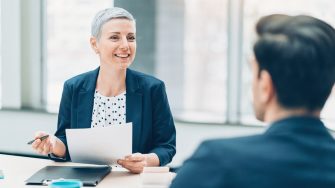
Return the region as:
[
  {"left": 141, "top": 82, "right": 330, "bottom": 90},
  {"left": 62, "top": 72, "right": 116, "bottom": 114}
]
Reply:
[{"left": 241, "top": 0, "right": 335, "bottom": 128}]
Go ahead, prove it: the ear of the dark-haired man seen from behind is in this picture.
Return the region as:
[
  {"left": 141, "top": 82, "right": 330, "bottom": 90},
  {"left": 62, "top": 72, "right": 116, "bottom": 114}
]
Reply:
[{"left": 259, "top": 70, "right": 275, "bottom": 103}]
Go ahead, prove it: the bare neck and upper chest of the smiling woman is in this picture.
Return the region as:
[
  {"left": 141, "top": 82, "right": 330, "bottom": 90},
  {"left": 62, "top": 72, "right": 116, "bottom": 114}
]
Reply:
[{"left": 96, "top": 66, "right": 126, "bottom": 96}]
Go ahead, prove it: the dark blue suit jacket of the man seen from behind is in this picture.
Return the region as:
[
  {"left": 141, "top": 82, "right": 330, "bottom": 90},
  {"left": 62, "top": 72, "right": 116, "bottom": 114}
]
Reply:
[{"left": 171, "top": 117, "right": 335, "bottom": 188}]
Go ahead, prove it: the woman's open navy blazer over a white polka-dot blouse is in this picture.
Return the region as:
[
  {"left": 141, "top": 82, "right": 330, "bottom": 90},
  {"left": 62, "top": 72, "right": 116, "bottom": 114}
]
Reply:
[{"left": 55, "top": 68, "right": 176, "bottom": 165}]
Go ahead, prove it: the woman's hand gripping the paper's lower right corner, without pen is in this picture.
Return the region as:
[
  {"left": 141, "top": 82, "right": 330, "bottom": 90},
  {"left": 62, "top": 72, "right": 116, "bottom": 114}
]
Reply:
[{"left": 117, "top": 153, "right": 159, "bottom": 174}]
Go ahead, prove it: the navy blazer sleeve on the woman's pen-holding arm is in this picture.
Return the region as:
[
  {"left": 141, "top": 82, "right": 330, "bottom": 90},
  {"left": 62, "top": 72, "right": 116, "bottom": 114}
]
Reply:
[{"left": 49, "top": 82, "right": 72, "bottom": 161}]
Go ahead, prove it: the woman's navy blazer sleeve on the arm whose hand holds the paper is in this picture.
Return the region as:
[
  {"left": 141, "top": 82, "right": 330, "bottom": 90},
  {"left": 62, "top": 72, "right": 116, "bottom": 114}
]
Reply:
[{"left": 151, "top": 82, "right": 176, "bottom": 166}]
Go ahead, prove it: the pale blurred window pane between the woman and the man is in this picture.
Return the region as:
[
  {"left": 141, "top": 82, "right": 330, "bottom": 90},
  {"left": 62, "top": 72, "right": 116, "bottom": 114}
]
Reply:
[{"left": 173, "top": 0, "right": 227, "bottom": 122}]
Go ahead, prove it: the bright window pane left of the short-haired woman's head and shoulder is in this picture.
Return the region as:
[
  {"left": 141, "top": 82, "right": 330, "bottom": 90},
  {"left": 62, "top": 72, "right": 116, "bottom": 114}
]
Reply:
[{"left": 46, "top": 0, "right": 113, "bottom": 112}]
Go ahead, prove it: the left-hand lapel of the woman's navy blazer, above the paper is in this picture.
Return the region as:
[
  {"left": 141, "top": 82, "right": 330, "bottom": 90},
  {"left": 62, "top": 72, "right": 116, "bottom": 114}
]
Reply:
[{"left": 77, "top": 68, "right": 99, "bottom": 128}]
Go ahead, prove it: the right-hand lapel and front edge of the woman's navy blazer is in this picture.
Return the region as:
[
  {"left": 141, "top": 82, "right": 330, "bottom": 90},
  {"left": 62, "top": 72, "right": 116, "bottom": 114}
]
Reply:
[{"left": 126, "top": 69, "right": 142, "bottom": 152}]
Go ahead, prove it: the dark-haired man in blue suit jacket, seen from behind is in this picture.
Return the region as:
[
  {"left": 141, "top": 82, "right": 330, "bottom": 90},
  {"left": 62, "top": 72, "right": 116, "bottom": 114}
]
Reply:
[{"left": 171, "top": 15, "right": 335, "bottom": 188}]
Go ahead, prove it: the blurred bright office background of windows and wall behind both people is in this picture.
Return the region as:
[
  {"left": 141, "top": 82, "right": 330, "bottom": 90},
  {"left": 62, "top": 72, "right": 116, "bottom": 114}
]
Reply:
[{"left": 0, "top": 0, "right": 335, "bottom": 166}]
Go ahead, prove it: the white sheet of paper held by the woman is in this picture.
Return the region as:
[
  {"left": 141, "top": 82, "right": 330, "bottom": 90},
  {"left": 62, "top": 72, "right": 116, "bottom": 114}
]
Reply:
[{"left": 66, "top": 123, "right": 133, "bottom": 165}]
